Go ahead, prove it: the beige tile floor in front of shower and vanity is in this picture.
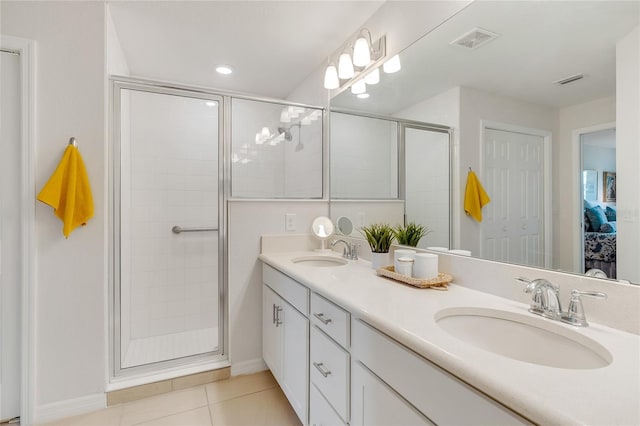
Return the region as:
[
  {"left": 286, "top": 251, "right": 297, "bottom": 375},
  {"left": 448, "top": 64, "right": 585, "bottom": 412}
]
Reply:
[{"left": 43, "top": 371, "right": 301, "bottom": 426}]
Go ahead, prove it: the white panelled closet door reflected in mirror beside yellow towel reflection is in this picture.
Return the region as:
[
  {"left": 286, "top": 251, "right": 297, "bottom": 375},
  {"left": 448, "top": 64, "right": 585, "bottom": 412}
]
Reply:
[{"left": 481, "top": 128, "right": 545, "bottom": 266}]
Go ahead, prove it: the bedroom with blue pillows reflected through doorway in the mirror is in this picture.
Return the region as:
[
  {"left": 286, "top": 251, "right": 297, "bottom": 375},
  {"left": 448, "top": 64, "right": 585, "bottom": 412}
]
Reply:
[{"left": 580, "top": 128, "right": 617, "bottom": 278}]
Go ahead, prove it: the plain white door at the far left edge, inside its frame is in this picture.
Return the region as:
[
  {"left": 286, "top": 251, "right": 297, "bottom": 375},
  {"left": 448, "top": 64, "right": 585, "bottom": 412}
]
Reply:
[{"left": 0, "top": 48, "right": 22, "bottom": 421}]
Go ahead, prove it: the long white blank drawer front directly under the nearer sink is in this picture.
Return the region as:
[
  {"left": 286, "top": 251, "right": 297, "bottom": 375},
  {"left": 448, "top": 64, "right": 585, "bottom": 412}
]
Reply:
[{"left": 351, "top": 320, "right": 530, "bottom": 425}]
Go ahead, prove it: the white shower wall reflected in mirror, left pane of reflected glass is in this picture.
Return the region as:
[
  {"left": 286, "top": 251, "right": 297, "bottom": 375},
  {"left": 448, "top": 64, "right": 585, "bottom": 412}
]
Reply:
[{"left": 331, "top": 114, "right": 398, "bottom": 199}]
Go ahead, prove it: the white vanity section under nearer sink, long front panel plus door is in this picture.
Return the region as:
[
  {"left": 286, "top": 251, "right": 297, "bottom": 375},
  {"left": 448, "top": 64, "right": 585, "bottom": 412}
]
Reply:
[{"left": 351, "top": 319, "right": 531, "bottom": 425}]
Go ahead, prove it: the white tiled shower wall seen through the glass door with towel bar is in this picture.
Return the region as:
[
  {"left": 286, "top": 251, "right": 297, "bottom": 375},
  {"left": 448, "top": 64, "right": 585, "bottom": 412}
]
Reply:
[{"left": 122, "top": 92, "right": 218, "bottom": 339}]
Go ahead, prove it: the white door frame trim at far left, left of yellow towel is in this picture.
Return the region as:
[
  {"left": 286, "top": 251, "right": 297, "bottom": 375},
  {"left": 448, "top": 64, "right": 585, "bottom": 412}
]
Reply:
[{"left": 0, "top": 35, "right": 36, "bottom": 424}]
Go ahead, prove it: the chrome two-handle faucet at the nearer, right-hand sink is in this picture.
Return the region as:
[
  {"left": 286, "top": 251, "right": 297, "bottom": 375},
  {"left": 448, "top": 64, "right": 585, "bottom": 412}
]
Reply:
[{"left": 516, "top": 277, "right": 607, "bottom": 327}]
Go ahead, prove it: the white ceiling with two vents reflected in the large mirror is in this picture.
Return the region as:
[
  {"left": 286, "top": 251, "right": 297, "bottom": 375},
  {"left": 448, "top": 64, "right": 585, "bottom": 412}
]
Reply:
[{"left": 331, "top": 1, "right": 640, "bottom": 115}]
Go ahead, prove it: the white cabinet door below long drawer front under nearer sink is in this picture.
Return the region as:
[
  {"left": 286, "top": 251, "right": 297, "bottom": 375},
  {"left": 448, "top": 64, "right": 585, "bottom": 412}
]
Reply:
[{"left": 350, "top": 362, "right": 433, "bottom": 426}]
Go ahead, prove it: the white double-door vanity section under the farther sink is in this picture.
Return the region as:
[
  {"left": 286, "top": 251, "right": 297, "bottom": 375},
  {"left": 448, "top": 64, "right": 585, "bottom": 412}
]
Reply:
[{"left": 262, "top": 265, "right": 309, "bottom": 424}]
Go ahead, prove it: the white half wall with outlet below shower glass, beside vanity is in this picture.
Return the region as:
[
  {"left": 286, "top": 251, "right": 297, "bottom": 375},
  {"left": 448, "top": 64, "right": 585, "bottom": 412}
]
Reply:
[{"left": 228, "top": 200, "right": 329, "bottom": 375}]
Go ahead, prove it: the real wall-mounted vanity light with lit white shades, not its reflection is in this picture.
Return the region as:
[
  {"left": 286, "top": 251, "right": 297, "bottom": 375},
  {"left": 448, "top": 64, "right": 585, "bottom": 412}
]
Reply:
[{"left": 324, "top": 28, "right": 387, "bottom": 90}]
